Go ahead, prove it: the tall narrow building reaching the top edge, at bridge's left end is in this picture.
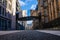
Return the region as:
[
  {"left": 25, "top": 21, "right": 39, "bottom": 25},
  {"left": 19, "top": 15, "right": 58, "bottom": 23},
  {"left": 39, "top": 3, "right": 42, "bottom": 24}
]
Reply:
[{"left": 16, "top": 0, "right": 25, "bottom": 30}]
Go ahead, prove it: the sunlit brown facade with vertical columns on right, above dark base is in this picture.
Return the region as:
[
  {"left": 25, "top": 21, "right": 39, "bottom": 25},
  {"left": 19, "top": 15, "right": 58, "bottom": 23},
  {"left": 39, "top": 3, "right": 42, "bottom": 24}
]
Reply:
[{"left": 38, "top": 0, "right": 60, "bottom": 28}]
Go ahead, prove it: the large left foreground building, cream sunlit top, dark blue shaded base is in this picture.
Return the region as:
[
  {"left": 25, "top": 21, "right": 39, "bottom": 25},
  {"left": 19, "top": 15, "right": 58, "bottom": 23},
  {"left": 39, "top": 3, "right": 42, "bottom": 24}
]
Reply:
[{"left": 0, "top": 0, "right": 16, "bottom": 30}]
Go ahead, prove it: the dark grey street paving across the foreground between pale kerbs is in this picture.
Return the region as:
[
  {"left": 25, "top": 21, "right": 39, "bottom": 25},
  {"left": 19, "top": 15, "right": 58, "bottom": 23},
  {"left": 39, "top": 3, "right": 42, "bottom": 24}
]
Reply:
[{"left": 0, "top": 30, "right": 60, "bottom": 40}]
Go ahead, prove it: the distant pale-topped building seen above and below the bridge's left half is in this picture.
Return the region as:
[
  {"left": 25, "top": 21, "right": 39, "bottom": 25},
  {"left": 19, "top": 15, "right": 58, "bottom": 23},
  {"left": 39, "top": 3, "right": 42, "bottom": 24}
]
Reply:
[{"left": 16, "top": 8, "right": 27, "bottom": 30}]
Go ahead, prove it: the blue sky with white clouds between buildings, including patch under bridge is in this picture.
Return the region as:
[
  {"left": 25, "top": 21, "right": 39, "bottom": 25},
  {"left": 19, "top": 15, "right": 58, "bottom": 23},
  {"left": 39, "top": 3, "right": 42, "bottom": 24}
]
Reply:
[{"left": 19, "top": 0, "right": 38, "bottom": 23}]
